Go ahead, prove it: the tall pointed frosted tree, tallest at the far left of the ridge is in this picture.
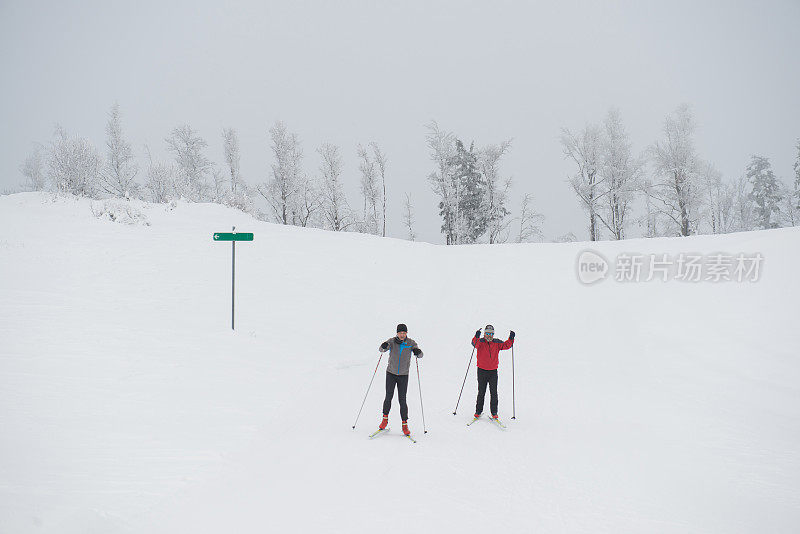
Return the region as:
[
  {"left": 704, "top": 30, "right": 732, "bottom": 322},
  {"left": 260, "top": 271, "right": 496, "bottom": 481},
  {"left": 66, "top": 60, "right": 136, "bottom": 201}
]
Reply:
[{"left": 102, "top": 103, "right": 139, "bottom": 198}]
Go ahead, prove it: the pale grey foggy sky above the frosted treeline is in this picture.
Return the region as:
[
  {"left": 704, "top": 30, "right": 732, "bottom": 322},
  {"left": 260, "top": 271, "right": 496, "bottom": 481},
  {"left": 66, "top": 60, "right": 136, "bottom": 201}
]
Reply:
[{"left": 0, "top": 0, "right": 800, "bottom": 243}]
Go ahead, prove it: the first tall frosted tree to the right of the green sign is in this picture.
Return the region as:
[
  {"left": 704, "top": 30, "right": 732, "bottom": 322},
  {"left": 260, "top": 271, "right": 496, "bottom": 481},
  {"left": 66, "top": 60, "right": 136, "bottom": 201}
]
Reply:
[{"left": 258, "top": 121, "right": 303, "bottom": 224}]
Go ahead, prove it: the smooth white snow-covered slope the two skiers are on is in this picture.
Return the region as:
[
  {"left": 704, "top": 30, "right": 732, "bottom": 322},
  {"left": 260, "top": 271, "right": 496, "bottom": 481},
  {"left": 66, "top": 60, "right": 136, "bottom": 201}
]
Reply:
[{"left": 0, "top": 194, "right": 800, "bottom": 533}]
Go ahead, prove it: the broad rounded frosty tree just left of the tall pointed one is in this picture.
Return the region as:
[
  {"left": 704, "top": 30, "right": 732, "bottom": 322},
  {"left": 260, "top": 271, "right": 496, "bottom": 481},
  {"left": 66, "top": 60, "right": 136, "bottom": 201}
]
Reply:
[{"left": 47, "top": 126, "right": 102, "bottom": 197}]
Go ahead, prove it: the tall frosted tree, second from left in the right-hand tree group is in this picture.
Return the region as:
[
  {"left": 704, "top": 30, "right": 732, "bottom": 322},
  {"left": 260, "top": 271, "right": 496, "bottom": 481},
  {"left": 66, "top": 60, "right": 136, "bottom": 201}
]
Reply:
[{"left": 594, "top": 108, "right": 643, "bottom": 240}]
